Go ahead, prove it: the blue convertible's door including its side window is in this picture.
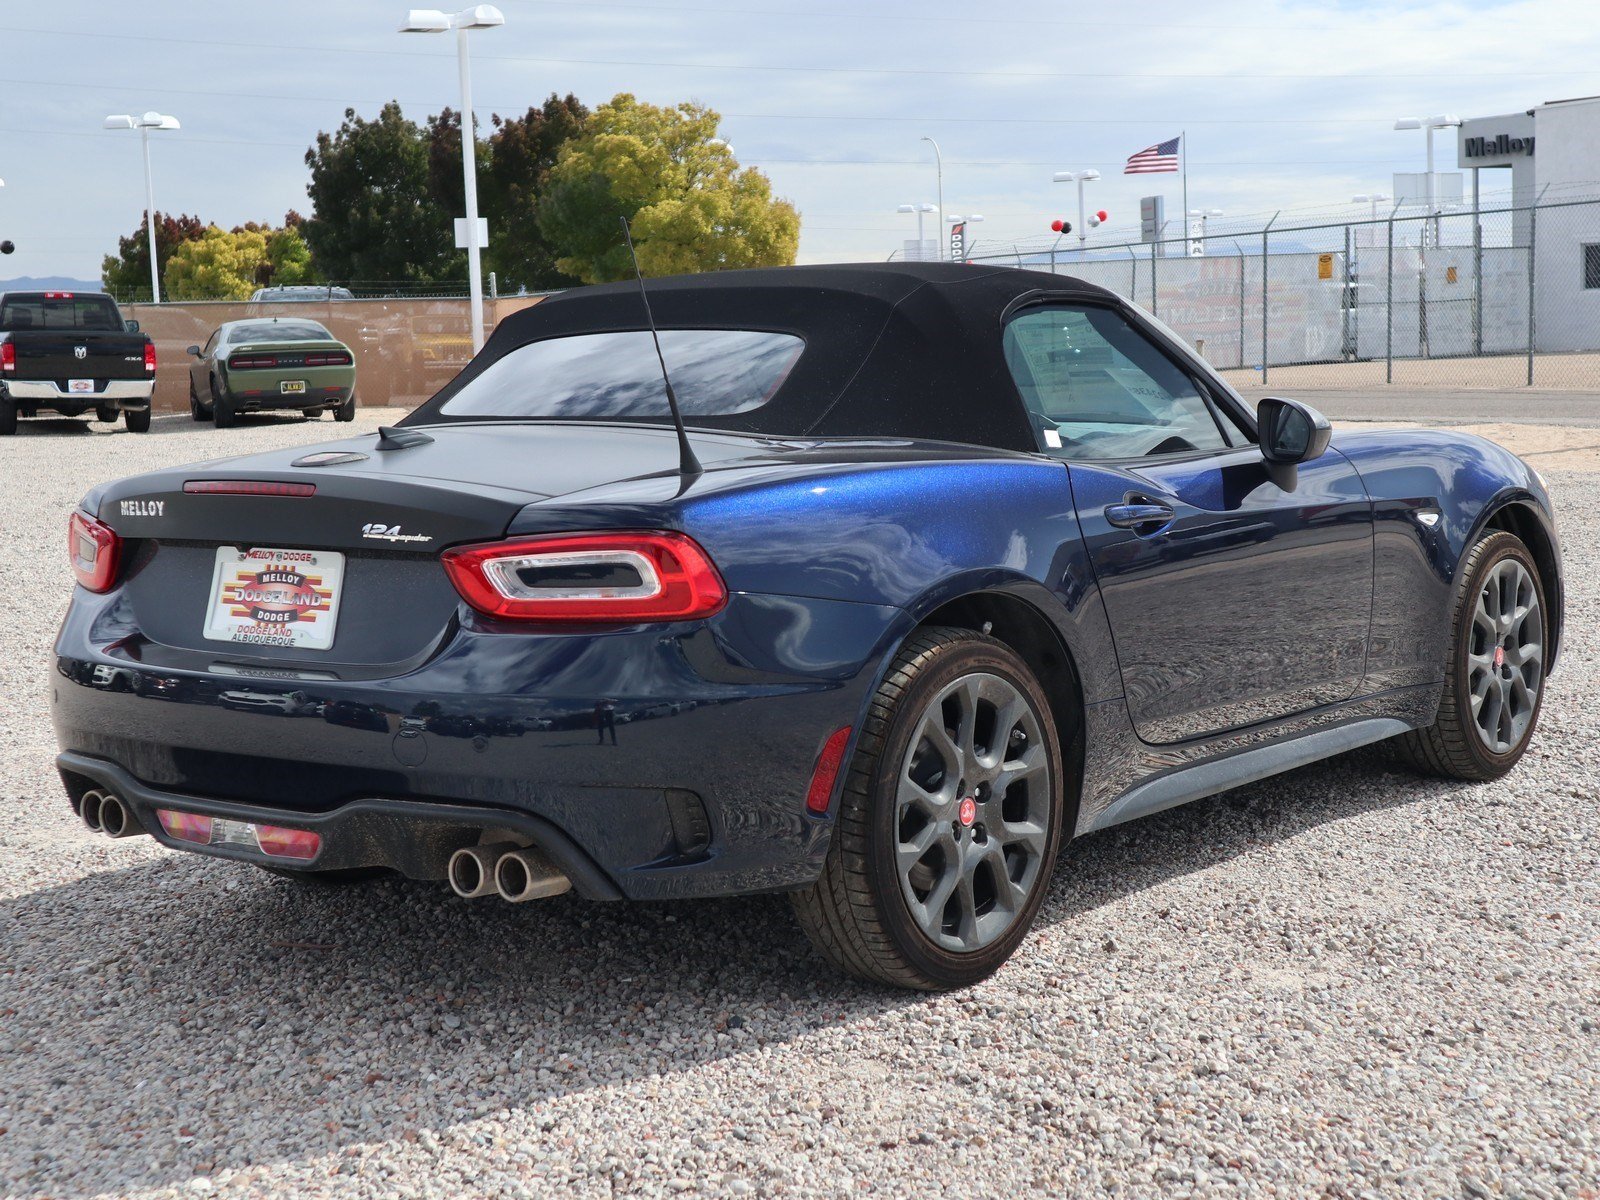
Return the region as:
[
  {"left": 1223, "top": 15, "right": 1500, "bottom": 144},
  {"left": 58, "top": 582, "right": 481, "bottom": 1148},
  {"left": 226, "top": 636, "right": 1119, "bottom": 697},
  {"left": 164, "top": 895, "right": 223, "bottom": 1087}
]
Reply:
[{"left": 1005, "top": 302, "right": 1373, "bottom": 742}]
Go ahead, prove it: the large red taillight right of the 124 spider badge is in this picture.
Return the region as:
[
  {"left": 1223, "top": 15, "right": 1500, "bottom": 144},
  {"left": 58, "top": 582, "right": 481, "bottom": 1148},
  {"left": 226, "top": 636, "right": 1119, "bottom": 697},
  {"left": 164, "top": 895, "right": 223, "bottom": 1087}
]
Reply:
[{"left": 443, "top": 533, "right": 728, "bottom": 621}]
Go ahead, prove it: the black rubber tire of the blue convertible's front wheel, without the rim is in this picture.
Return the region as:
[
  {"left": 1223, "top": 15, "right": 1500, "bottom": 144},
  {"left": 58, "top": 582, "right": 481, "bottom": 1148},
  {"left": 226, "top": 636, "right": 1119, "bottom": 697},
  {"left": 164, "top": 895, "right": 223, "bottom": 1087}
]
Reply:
[{"left": 1392, "top": 531, "right": 1550, "bottom": 781}]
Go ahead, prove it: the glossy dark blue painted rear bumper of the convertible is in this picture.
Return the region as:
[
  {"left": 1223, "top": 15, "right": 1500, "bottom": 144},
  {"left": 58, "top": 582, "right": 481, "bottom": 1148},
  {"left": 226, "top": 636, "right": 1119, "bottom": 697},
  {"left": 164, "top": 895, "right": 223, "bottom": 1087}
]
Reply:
[{"left": 51, "top": 590, "right": 906, "bottom": 899}]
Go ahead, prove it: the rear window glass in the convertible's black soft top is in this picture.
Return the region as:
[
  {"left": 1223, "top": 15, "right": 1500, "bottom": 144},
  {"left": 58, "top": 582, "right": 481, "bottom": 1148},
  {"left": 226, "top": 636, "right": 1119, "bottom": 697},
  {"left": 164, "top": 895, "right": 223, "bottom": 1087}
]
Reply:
[{"left": 438, "top": 330, "right": 805, "bottom": 419}]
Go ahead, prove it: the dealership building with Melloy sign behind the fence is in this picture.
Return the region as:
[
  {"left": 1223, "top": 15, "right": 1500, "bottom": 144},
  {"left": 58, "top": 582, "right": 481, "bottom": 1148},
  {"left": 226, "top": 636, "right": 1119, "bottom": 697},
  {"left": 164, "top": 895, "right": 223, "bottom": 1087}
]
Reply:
[{"left": 1456, "top": 96, "right": 1600, "bottom": 350}]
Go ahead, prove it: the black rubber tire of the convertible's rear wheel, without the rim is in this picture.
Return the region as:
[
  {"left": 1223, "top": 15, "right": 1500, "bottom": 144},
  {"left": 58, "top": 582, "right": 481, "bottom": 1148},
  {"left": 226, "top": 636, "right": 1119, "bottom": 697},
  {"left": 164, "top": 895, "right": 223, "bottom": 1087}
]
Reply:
[{"left": 792, "top": 627, "right": 1066, "bottom": 990}]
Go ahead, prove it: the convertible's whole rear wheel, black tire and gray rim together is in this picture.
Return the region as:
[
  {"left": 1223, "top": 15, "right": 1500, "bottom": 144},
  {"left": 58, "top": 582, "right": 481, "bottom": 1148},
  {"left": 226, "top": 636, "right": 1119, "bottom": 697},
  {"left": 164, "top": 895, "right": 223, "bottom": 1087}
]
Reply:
[{"left": 790, "top": 626, "right": 1066, "bottom": 990}]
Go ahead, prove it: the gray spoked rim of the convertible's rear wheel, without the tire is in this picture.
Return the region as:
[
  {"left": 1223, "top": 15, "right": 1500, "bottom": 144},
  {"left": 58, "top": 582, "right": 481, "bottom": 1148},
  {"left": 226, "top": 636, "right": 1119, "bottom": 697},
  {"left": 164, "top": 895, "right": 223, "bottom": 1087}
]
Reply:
[{"left": 894, "top": 672, "right": 1054, "bottom": 952}]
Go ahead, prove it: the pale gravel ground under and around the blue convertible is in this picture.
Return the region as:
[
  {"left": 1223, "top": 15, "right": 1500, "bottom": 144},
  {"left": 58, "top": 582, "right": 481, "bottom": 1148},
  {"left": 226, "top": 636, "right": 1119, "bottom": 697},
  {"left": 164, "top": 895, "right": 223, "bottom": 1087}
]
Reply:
[{"left": 0, "top": 413, "right": 1600, "bottom": 1200}]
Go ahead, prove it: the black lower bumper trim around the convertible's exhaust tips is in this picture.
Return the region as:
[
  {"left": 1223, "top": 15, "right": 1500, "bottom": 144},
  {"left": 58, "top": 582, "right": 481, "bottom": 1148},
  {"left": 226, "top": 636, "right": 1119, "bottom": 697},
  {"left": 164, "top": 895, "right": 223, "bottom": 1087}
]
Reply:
[{"left": 56, "top": 754, "right": 622, "bottom": 901}]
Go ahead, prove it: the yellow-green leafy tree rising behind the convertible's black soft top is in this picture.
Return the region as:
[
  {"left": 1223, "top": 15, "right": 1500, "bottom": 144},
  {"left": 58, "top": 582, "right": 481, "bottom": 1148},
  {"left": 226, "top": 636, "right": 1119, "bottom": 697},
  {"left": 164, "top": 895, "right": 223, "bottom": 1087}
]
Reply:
[{"left": 538, "top": 93, "right": 800, "bottom": 283}]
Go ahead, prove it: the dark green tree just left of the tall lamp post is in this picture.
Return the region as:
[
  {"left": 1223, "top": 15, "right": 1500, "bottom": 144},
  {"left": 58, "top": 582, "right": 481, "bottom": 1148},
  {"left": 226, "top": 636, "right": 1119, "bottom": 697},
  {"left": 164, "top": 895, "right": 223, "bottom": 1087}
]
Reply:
[{"left": 301, "top": 101, "right": 466, "bottom": 283}]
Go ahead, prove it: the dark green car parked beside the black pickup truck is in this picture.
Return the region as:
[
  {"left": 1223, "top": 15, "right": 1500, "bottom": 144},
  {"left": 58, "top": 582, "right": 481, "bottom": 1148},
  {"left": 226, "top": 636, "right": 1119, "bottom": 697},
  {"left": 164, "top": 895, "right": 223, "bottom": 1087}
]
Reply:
[{"left": 189, "top": 317, "right": 355, "bottom": 429}]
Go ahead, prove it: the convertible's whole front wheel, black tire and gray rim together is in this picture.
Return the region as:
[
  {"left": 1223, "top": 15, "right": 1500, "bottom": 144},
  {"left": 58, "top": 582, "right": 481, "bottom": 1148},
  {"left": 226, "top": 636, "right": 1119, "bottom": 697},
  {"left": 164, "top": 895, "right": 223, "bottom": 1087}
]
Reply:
[{"left": 1392, "top": 530, "right": 1549, "bottom": 781}]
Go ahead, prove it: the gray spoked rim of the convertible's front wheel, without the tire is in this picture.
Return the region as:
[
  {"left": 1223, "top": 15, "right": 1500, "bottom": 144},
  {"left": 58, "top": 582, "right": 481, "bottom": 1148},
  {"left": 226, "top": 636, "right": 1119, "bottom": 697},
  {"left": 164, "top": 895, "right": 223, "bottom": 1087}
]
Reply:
[{"left": 1467, "top": 558, "right": 1544, "bottom": 754}]
